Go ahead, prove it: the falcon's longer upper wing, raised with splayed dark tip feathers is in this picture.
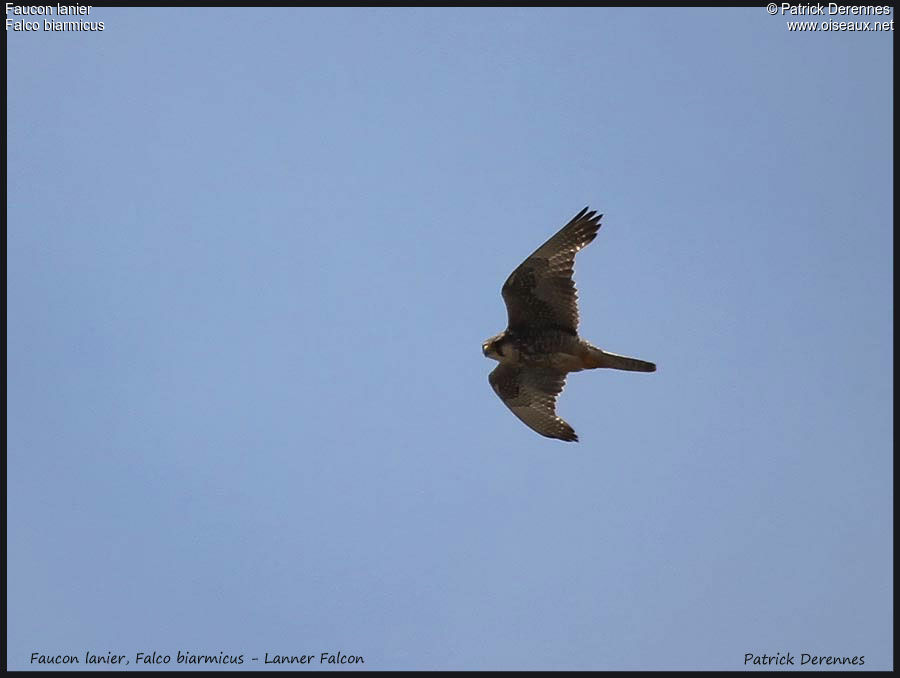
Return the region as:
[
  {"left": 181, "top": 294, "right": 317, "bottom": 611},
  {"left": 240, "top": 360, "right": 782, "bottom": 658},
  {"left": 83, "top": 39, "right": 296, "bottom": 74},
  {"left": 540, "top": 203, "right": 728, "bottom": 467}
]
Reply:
[{"left": 502, "top": 207, "right": 603, "bottom": 334}]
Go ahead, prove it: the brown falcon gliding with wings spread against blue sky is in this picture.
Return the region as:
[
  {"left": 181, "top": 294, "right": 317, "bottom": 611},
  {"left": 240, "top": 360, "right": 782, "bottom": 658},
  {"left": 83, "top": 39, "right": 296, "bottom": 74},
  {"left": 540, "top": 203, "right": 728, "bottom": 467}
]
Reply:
[{"left": 481, "top": 207, "right": 656, "bottom": 442}]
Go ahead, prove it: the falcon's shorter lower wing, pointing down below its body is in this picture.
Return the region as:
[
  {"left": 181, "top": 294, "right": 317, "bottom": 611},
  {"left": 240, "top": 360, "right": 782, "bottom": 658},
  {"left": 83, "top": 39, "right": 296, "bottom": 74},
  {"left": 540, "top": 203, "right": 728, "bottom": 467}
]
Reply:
[{"left": 488, "top": 363, "right": 578, "bottom": 442}]
